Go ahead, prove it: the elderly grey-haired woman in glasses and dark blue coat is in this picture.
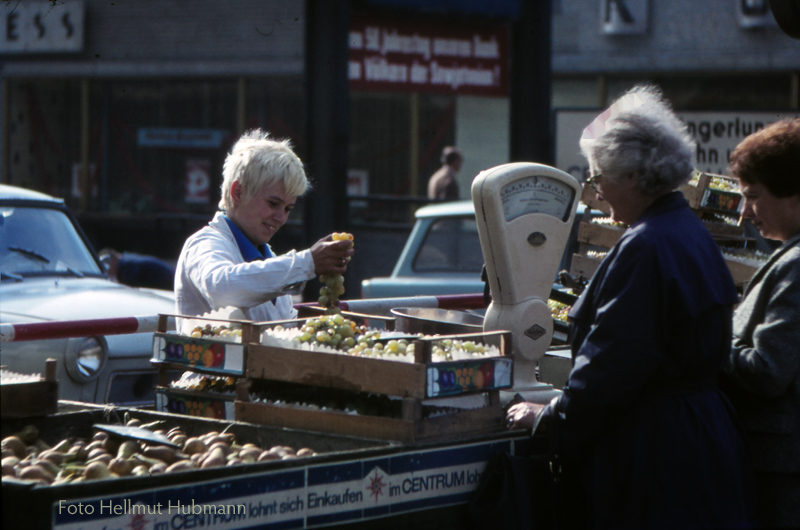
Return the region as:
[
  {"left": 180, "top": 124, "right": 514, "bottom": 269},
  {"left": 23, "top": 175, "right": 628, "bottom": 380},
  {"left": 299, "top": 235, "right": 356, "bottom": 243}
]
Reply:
[{"left": 508, "top": 87, "right": 752, "bottom": 530}]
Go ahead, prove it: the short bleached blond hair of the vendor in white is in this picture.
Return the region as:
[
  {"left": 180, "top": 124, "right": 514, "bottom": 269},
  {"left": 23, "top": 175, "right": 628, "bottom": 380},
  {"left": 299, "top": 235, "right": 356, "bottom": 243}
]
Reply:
[{"left": 219, "top": 129, "right": 311, "bottom": 211}]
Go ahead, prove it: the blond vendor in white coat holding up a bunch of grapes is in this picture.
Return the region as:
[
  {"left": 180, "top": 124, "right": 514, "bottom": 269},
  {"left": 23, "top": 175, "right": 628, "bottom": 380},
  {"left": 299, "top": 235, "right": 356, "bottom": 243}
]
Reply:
[{"left": 175, "top": 130, "right": 353, "bottom": 322}]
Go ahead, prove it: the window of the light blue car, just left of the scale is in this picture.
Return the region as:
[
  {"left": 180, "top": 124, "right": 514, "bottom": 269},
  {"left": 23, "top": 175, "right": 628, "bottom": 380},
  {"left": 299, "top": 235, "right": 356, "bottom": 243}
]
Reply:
[{"left": 413, "top": 217, "right": 483, "bottom": 274}]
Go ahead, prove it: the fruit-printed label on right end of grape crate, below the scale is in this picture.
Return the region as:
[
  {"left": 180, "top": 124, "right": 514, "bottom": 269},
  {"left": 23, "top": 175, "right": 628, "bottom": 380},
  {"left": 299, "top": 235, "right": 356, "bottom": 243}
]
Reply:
[{"left": 425, "top": 358, "right": 513, "bottom": 397}]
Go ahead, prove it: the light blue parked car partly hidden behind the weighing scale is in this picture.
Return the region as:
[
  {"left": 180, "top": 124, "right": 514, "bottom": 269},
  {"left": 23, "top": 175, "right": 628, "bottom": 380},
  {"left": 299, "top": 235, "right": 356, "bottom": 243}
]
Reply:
[{"left": 361, "top": 201, "right": 592, "bottom": 298}]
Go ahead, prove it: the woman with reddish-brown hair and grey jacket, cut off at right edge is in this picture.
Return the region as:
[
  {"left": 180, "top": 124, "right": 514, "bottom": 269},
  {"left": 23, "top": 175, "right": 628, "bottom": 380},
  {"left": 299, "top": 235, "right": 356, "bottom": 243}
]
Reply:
[{"left": 724, "top": 119, "right": 800, "bottom": 528}]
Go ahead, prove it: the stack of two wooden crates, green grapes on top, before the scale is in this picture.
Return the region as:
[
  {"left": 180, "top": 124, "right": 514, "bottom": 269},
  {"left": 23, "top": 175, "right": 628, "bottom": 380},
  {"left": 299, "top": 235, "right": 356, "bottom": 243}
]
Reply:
[{"left": 235, "top": 315, "right": 513, "bottom": 442}]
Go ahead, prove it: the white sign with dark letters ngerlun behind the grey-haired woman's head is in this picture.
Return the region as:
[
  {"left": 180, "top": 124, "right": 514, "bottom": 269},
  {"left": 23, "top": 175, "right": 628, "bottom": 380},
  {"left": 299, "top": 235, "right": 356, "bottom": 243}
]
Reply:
[{"left": 556, "top": 110, "right": 800, "bottom": 181}]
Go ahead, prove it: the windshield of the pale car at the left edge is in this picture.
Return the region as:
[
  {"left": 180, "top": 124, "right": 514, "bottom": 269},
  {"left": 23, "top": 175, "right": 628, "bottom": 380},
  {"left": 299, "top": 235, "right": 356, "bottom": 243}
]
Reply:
[{"left": 0, "top": 206, "right": 102, "bottom": 278}]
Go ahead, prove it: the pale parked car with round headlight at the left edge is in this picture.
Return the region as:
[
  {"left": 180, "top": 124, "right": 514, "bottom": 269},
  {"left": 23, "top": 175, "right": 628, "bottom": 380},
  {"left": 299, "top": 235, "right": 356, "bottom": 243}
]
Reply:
[{"left": 0, "top": 185, "right": 175, "bottom": 405}]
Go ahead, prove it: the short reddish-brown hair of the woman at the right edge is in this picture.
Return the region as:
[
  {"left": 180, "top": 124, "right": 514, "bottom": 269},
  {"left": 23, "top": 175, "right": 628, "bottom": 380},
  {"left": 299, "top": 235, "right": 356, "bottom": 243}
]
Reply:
[{"left": 729, "top": 118, "right": 800, "bottom": 198}]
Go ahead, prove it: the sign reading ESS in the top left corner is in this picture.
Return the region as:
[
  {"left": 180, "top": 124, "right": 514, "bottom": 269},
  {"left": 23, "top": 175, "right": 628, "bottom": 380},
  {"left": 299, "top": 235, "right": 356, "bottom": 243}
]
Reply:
[{"left": 0, "top": 0, "right": 84, "bottom": 54}]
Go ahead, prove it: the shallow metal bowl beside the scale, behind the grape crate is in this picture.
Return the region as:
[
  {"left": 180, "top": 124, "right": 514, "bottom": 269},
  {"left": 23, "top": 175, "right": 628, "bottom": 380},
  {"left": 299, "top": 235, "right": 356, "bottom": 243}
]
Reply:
[{"left": 392, "top": 307, "right": 483, "bottom": 335}]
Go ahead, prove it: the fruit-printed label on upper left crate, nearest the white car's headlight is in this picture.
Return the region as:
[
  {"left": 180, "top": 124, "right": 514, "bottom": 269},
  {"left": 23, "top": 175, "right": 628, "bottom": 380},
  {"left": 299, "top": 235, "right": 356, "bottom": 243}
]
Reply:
[{"left": 153, "top": 334, "right": 244, "bottom": 375}]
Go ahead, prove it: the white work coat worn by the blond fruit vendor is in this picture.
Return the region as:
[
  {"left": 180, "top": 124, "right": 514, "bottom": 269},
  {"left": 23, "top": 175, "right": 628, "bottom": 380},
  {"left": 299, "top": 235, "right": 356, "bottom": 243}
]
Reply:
[{"left": 175, "top": 212, "right": 316, "bottom": 322}]
